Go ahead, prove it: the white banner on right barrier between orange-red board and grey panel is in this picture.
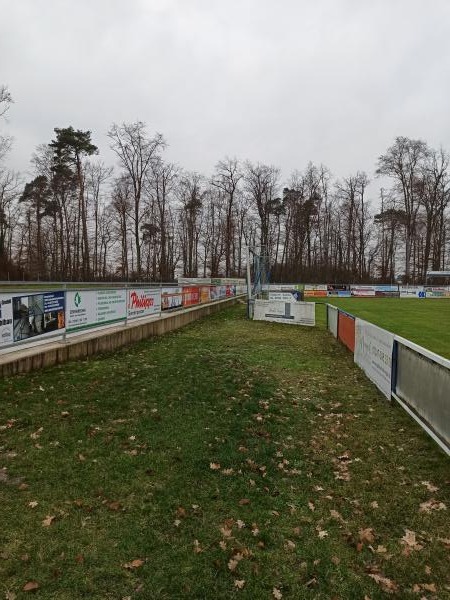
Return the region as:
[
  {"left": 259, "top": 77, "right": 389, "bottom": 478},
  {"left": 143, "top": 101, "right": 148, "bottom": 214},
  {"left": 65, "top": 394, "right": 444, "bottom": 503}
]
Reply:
[{"left": 354, "top": 319, "right": 394, "bottom": 399}]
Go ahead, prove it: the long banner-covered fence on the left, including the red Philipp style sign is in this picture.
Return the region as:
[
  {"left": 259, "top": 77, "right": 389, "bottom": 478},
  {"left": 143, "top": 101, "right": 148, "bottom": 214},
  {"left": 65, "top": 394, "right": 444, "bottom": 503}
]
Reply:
[{"left": 0, "top": 280, "right": 246, "bottom": 354}]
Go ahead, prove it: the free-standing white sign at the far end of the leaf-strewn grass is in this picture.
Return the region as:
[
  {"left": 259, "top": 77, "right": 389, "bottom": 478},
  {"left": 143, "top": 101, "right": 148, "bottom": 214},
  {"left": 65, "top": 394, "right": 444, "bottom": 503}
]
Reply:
[{"left": 253, "top": 300, "right": 316, "bottom": 326}]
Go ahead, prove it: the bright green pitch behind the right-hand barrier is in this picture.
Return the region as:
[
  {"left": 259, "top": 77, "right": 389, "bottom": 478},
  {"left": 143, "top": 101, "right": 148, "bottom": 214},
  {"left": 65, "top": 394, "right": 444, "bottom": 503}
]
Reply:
[{"left": 320, "top": 298, "right": 450, "bottom": 358}]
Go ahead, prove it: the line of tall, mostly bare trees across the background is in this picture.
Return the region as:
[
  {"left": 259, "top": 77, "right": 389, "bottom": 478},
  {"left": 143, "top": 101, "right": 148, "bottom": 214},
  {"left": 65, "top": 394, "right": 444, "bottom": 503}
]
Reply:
[{"left": 0, "top": 87, "right": 450, "bottom": 282}]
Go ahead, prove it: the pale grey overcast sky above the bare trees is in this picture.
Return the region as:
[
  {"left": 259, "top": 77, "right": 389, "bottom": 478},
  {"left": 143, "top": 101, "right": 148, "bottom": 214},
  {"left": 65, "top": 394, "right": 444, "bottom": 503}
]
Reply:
[{"left": 0, "top": 0, "right": 450, "bottom": 196}]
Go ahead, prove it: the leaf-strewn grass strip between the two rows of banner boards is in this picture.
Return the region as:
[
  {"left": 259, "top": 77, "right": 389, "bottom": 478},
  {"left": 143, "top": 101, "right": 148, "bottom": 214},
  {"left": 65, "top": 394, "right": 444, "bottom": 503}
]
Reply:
[{"left": 0, "top": 306, "right": 450, "bottom": 600}]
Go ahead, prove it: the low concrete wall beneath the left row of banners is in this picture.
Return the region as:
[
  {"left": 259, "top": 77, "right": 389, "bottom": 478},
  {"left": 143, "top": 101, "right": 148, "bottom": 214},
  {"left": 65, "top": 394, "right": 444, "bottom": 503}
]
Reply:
[{"left": 0, "top": 298, "right": 239, "bottom": 377}]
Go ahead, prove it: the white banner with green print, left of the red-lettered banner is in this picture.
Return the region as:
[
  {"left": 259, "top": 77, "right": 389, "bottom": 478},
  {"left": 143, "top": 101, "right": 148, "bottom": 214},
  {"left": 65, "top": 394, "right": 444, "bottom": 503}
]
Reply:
[{"left": 66, "top": 289, "right": 127, "bottom": 332}]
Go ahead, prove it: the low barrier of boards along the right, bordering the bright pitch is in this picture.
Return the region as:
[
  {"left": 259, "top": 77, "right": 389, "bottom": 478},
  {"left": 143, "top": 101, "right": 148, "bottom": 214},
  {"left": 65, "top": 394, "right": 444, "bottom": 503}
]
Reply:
[{"left": 327, "top": 304, "right": 450, "bottom": 455}]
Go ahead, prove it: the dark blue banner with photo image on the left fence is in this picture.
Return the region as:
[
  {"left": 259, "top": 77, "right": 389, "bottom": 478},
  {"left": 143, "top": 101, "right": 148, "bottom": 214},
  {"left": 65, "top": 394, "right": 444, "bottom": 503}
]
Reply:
[{"left": 11, "top": 292, "right": 65, "bottom": 343}]
